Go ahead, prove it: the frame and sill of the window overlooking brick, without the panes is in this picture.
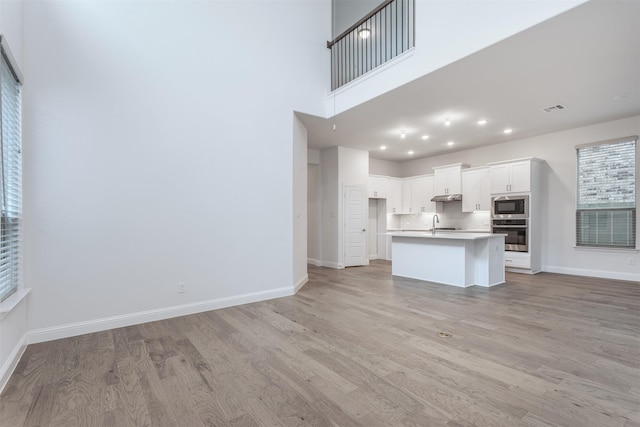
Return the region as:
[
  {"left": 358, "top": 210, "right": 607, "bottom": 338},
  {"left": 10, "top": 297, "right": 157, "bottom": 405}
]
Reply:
[{"left": 574, "top": 135, "right": 638, "bottom": 251}]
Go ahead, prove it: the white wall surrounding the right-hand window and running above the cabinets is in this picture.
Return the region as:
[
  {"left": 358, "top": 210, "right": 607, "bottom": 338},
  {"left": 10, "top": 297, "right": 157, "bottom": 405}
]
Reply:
[{"left": 401, "top": 116, "right": 640, "bottom": 281}]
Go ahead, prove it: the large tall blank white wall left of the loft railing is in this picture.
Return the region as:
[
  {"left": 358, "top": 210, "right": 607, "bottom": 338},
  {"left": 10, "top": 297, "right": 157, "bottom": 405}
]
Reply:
[{"left": 23, "top": 0, "right": 330, "bottom": 341}]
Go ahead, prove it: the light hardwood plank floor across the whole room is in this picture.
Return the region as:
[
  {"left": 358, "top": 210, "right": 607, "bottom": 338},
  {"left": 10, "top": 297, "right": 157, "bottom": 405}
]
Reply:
[{"left": 0, "top": 261, "right": 640, "bottom": 427}]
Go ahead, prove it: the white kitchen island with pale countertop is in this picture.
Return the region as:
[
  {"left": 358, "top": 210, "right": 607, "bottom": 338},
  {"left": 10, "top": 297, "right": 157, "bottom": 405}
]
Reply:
[{"left": 388, "top": 231, "right": 505, "bottom": 287}]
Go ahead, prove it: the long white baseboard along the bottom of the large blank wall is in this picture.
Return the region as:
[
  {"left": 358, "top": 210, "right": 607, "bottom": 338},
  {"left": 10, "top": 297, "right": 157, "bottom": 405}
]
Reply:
[{"left": 27, "top": 287, "right": 295, "bottom": 344}]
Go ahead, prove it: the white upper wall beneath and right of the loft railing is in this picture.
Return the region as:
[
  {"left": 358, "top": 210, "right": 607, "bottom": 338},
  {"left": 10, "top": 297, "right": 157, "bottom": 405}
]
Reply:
[{"left": 325, "top": 0, "right": 585, "bottom": 117}]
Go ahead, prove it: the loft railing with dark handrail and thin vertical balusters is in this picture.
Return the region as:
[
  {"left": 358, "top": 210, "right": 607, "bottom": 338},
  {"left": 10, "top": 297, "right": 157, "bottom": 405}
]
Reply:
[{"left": 327, "top": 0, "right": 415, "bottom": 90}]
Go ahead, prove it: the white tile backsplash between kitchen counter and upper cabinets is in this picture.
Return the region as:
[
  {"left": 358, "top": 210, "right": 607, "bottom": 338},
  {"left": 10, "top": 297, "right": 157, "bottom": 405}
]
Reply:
[{"left": 387, "top": 202, "right": 491, "bottom": 231}]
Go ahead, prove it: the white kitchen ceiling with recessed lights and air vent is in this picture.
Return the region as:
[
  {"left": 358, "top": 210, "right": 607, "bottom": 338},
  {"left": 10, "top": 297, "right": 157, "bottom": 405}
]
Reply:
[{"left": 299, "top": 0, "right": 640, "bottom": 161}]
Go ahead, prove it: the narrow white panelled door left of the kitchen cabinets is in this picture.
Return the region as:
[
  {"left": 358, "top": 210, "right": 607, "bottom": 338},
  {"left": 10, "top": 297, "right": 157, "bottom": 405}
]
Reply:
[{"left": 342, "top": 185, "right": 369, "bottom": 267}]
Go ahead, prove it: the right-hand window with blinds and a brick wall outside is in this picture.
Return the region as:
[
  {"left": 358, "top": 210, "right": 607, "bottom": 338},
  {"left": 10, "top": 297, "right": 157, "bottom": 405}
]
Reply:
[{"left": 576, "top": 136, "right": 638, "bottom": 248}]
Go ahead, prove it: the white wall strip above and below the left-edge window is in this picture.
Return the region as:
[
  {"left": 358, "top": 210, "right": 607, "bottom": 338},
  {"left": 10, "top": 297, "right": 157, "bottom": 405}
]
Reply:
[{"left": 0, "top": 0, "right": 29, "bottom": 391}]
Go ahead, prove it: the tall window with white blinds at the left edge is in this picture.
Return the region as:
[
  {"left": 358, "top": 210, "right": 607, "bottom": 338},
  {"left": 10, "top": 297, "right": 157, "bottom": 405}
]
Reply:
[{"left": 0, "top": 36, "right": 22, "bottom": 301}]
